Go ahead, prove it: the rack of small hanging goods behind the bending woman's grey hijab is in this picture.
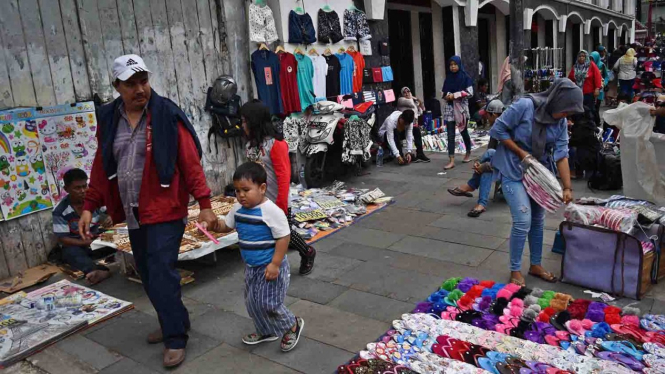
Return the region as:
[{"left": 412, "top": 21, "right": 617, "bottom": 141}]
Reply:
[{"left": 524, "top": 47, "right": 565, "bottom": 92}]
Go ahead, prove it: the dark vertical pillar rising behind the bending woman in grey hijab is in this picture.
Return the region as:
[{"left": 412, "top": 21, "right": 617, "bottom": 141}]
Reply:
[{"left": 510, "top": 0, "right": 524, "bottom": 98}]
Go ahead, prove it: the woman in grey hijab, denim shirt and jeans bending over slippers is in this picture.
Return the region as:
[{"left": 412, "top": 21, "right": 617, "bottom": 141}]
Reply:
[{"left": 490, "top": 78, "right": 584, "bottom": 285}]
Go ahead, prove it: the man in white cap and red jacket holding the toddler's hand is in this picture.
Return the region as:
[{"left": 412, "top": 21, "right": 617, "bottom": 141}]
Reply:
[{"left": 79, "top": 55, "right": 217, "bottom": 367}]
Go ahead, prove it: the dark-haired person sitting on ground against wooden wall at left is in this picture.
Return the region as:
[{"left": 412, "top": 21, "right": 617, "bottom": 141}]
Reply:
[{"left": 52, "top": 169, "right": 111, "bottom": 284}]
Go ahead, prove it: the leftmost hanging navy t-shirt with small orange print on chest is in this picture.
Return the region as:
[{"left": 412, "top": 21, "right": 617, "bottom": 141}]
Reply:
[{"left": 251, "top": 49, "right": 282, "bottom": 114}]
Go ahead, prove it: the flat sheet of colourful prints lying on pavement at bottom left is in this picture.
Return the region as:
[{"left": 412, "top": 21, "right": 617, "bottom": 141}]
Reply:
[{"left": 0, "top": 280, "right": 132, "bottom": 367}]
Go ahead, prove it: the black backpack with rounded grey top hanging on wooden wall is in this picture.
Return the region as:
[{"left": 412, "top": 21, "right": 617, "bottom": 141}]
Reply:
[{"left": 205, "top": 75, "right": 242, "bottom": 153}]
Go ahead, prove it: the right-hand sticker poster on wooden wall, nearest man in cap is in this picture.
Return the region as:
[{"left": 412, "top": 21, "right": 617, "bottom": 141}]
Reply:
[{"left": 35, "top": 102, "right": 97, "bottom": 204}]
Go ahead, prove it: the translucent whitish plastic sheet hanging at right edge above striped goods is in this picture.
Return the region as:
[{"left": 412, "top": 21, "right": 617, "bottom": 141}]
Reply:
[{"left": 603, "top": 102, "right": 665, "bottom": 205}]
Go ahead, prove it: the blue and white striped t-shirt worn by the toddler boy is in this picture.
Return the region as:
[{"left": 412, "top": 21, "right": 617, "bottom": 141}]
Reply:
[{"left": 226, "top": 200, "right": 291, "bottom": 266}]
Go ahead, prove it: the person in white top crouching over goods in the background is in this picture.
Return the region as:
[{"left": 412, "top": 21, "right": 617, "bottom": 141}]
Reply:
[{"left": 379, "top": 109, "right": 429, "bottom": 165}]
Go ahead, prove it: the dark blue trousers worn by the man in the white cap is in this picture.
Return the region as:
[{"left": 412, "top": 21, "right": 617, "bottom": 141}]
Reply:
[{"left": 129, "top": 220, "right": 189, "bottom": 349}]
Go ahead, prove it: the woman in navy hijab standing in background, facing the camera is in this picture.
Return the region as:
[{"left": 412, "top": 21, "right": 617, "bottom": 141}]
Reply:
[{"left": 441, "top": 56, "right": 473, "bottom": 170}]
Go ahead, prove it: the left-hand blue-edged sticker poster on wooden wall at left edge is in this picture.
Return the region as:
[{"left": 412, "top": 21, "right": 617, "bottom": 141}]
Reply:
[{"left": 0, "top": 109, "right": 53, "bottom": 219}]
